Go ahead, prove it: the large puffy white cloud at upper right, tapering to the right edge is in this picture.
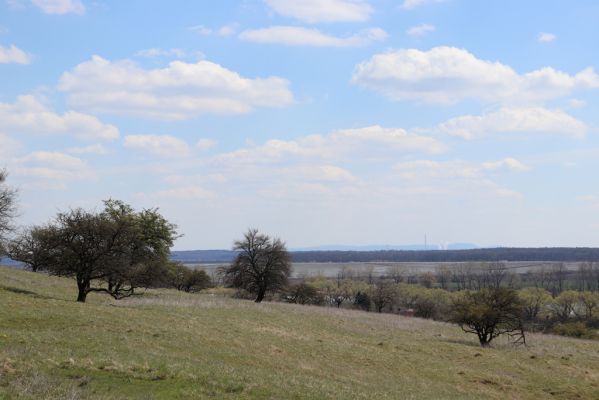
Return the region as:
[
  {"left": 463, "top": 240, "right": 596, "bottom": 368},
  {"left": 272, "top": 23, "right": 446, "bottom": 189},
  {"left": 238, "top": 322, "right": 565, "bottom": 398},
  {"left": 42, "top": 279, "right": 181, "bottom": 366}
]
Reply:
[{"left": 352, "top": 47, "right": 599, "bottom": 104}]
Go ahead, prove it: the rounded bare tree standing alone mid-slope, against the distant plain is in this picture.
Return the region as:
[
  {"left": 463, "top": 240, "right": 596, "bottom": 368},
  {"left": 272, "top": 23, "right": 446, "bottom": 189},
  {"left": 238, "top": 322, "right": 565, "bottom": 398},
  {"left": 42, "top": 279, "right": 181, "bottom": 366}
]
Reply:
[{"left": 224, "top": 229, "right": 291, "bottom": 303}]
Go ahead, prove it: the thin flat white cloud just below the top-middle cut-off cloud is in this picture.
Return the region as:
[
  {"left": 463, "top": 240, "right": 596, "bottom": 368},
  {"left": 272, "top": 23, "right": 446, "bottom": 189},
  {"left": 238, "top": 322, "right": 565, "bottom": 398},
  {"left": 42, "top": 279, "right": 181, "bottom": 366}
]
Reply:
[{"left": 239, "top": 26, "right": 387, "bottom": 47}]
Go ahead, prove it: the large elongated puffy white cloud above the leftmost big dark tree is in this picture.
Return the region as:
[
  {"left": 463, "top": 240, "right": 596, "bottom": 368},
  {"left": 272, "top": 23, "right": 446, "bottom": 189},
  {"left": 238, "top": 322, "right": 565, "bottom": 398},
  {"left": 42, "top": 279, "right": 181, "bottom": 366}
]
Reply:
[{"left": 59, "top": 56, "right": 293, "bottom": 120}]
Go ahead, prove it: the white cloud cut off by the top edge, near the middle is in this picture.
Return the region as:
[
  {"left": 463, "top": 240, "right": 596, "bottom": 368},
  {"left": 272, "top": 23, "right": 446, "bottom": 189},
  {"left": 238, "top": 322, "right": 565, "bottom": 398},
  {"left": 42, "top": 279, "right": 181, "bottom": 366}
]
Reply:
[{"left": 265, "top": 0, "right": 374, "bottom": 23}]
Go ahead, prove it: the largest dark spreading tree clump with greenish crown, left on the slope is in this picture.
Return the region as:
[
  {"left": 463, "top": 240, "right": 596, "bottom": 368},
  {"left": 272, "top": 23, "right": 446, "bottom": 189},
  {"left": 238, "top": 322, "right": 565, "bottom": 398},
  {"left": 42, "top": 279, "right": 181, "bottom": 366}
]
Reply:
[{"left": 9, "top": 200, "right": 177, "bottom": 302}]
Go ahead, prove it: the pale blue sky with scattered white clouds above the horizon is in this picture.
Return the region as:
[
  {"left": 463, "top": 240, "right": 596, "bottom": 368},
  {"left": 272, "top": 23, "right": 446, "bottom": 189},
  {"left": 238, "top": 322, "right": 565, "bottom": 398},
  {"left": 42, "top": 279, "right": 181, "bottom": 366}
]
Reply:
[{"left": 0, "top": 0, "right": 599, "bottom": 250}]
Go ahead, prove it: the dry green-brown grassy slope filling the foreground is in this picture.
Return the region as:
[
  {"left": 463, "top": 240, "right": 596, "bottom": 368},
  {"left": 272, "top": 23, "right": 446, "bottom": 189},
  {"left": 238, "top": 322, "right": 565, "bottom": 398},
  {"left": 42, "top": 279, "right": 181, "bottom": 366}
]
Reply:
[{"left": 0, "top": 268, "right": 599, "bottom": 399}]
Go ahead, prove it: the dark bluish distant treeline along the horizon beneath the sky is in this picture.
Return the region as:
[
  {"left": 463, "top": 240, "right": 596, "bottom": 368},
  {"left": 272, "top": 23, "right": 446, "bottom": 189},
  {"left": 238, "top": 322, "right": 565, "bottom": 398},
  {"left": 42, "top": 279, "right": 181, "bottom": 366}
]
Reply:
[{"left": 171, "top": 247, "right": 599, "bottom": 263}]
